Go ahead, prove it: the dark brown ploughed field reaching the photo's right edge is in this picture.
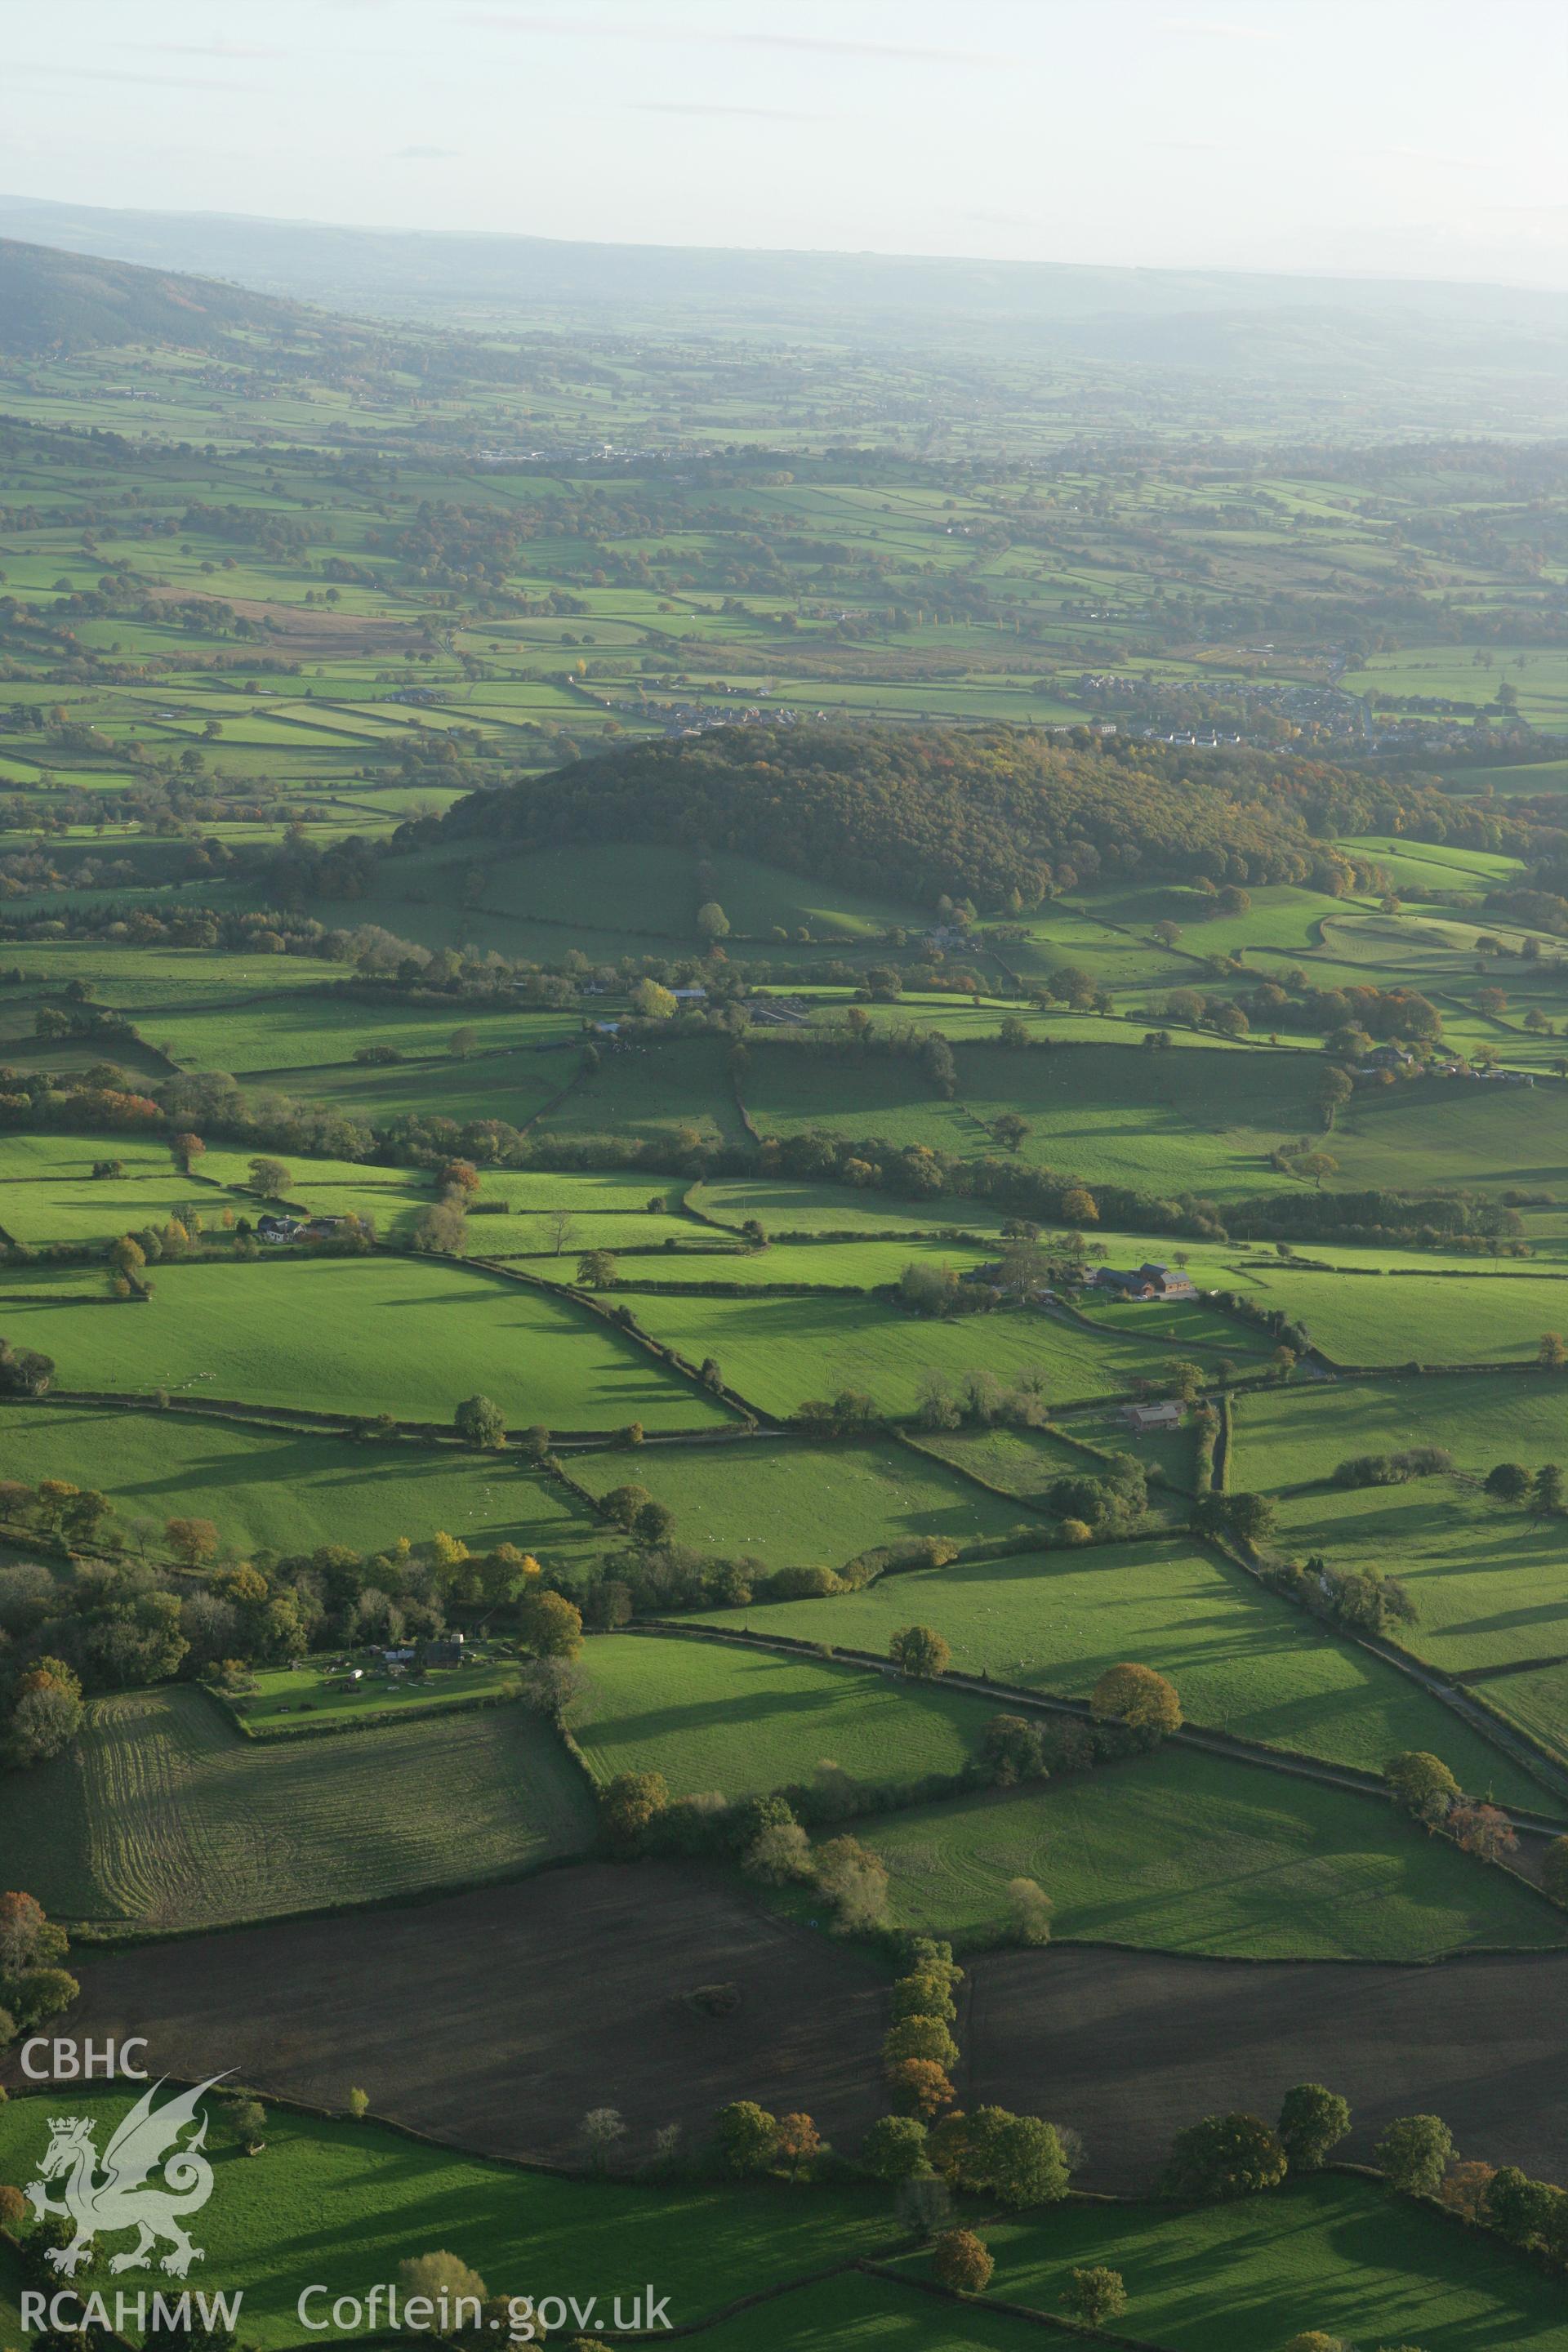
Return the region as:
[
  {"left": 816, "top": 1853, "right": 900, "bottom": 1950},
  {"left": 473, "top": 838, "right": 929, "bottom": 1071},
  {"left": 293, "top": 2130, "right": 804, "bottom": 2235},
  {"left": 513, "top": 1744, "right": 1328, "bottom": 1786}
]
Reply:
[{"left": 961, "top": 1945, "right": 1568, "bottom": 2187}]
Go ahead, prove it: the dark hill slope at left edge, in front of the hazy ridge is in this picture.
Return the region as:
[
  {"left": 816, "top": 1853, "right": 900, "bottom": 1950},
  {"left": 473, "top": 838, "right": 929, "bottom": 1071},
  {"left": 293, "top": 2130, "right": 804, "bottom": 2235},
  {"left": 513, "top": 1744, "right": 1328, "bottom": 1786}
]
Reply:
[{"left": 0, "top": 238, "right": 303, "bottom": 358}]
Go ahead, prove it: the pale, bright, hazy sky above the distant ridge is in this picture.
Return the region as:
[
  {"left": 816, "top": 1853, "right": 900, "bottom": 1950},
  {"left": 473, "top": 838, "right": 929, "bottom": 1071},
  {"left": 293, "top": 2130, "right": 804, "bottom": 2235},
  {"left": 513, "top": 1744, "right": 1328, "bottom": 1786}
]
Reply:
[{"left": 0, "top": 0, "right": 1568, "bottom": 287}]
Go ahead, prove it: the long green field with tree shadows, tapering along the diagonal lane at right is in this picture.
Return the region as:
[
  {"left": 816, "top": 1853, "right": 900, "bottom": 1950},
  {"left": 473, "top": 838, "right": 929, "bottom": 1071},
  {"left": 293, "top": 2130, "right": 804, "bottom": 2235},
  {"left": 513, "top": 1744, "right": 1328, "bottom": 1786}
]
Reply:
[{"left": 715, "top": 1540, "right": 1544, "bottom": 1804}]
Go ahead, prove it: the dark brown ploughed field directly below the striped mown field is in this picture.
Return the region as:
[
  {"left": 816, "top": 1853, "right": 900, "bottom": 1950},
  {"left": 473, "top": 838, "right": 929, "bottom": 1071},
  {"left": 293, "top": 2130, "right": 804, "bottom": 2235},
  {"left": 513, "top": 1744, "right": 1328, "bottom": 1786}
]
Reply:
[{"left": 30, "top": 1863, "right": 886, "bottom": 2164}]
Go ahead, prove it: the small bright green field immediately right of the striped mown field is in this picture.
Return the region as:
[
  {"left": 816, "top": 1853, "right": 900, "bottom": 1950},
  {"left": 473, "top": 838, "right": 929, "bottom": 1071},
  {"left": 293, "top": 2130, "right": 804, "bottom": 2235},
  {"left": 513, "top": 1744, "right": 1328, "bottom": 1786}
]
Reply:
[{"left": 573, "top": 1635, "right": 992, "bottom": 1797}]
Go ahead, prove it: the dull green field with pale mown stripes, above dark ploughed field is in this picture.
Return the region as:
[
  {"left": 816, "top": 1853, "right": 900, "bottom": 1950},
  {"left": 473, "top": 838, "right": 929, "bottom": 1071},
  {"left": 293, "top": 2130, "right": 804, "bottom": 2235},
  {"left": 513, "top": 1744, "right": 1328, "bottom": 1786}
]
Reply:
[{"left": 0, "top": 1686, "right": 592, "bottom": 1931}]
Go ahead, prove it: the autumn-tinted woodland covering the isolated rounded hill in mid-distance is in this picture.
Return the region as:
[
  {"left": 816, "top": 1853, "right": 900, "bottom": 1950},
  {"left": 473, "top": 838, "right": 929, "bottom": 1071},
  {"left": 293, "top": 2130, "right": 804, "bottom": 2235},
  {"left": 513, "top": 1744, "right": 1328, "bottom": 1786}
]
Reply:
[{"left": 413, "top": 727, "right": 1504, "bottom": 908}]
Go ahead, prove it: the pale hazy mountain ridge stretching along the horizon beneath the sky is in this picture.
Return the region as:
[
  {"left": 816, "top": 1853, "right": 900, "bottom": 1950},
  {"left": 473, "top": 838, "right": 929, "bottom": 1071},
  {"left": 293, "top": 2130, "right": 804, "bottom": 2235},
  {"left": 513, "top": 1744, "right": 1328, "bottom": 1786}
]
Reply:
[{"left": 0, "top": 195, "right": 1568, "bottom": 372}]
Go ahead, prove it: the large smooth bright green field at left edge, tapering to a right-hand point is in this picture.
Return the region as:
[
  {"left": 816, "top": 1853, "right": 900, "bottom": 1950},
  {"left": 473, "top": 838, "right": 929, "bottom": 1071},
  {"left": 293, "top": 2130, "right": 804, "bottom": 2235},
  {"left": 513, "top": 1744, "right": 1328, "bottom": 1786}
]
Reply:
[{"left": 0, "top": 1258, "right": 726, "bottom": 1428}]
